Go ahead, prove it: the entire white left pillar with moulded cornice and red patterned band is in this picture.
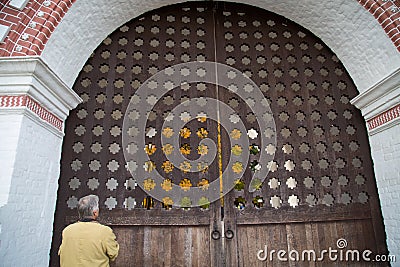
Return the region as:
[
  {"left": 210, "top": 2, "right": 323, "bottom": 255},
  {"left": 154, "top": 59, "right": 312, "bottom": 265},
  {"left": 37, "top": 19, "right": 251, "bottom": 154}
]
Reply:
[{"left": 0, "top": 58, "right": 81, "bottom": 266}]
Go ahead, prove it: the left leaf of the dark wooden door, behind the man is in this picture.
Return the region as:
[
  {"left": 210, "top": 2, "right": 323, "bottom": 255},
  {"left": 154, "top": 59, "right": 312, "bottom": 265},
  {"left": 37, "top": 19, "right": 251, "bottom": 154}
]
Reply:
[{"left": 51, "top": 3, "right": 221, "bottom": 266}]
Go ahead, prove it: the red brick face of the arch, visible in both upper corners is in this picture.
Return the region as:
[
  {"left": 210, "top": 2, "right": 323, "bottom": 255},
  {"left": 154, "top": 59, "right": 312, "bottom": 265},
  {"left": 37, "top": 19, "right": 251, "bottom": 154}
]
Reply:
[{"left": 0, "top": 0, "right": 400, "bottom": 57}]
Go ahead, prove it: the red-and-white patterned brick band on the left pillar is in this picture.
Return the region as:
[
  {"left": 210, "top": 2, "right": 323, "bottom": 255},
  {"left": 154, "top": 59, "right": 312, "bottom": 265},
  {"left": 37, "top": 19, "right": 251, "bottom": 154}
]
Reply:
[{"left": 0, "top": 95, "right": 63, "bottom": 132}]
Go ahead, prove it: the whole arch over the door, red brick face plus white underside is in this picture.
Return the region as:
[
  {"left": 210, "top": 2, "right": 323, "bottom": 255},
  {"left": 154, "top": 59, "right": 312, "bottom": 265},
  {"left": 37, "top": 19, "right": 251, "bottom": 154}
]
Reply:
[{"left": 0, "top": 0, "right": 400, "bottom": 91}]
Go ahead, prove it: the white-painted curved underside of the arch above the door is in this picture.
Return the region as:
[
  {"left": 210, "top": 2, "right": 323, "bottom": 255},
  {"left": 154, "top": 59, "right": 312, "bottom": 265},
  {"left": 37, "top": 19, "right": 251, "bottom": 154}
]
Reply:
[{"left": 42, "top": 0, "right": 400, "bottom": 92}]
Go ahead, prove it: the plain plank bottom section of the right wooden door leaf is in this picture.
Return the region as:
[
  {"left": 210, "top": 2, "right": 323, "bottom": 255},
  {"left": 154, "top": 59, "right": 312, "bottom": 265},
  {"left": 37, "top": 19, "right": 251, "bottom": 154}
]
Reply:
[{"left": 237, "top": 220, "right": 380, "bottom": 266}]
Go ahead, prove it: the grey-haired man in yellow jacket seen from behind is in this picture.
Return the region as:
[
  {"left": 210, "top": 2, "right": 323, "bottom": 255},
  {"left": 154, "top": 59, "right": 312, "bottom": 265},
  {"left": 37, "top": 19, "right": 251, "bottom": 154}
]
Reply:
[{"left": 58, "top": 195, "right": 119, "bottom": 267}]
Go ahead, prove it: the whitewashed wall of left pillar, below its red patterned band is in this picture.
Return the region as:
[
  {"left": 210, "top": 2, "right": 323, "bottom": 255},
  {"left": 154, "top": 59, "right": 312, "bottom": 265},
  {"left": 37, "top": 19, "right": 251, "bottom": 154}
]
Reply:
[{"left": 0, "top": 110, "right": 62, "bottom": 267}]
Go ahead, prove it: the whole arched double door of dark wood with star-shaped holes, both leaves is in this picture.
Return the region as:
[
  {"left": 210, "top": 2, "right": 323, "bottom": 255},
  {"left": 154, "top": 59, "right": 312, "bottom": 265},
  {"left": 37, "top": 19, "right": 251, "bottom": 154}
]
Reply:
[{"left": 51, "top": 2, "right": 385, "bottom": 266}]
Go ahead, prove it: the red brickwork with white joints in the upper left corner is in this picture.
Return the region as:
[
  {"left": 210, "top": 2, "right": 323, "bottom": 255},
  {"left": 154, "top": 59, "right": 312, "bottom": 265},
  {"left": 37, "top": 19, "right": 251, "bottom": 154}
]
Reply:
[{"left": 0, "top": 0, "right": 76, "bottom": 57}]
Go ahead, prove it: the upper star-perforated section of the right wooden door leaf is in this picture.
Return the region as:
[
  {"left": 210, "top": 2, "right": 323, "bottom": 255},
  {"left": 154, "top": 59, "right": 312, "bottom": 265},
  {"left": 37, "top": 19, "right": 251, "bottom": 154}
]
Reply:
[{"left": 216, "top": 0, "right": 376, "bottom": 221}]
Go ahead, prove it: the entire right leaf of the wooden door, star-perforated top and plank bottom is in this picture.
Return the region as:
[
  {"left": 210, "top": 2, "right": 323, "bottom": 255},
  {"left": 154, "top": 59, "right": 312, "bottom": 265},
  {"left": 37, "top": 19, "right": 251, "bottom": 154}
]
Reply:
[{"left": 214, "top": 3, "right": 386, "bottom": 266}]
